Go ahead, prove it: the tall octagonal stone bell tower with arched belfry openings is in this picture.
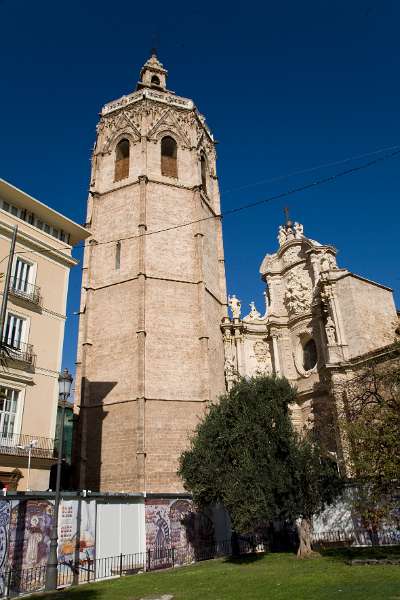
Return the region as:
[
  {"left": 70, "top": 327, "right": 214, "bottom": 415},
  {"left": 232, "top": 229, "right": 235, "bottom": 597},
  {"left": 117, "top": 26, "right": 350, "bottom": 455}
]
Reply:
[{"left": 76, "top": 53, "right": 226, "bottom": 492}]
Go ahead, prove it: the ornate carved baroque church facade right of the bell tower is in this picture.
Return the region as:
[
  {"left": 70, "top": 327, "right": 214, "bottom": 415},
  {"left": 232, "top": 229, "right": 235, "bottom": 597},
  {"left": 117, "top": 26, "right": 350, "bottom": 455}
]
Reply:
[{"left": 222, "top": 220, "right": 399, "bottom": 474}]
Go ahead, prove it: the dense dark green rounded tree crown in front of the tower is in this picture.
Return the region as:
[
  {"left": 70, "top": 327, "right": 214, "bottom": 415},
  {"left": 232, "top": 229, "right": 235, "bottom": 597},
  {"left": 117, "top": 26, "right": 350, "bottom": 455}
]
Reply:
[{"left": 179, "top": 376, "right": 341, "bottom": 533}]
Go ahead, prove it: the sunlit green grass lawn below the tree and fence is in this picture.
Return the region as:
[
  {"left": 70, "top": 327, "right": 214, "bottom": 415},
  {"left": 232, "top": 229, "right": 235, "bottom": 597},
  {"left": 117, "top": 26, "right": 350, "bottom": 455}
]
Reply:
[{"left": 35, "top": 548, "right": 400, "bottom": 600}]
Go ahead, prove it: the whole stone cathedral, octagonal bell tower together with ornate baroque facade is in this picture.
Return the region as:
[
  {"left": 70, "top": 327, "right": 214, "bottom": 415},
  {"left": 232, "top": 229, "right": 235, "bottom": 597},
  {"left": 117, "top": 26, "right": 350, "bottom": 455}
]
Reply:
[{"left": 76, "top": 54, "right": 398, "bottom": 495}]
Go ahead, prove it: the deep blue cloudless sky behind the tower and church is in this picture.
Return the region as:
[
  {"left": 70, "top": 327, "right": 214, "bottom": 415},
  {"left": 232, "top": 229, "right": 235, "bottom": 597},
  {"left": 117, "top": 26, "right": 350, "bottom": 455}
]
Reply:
[{"left": 0, "top": 0, "right": 400, "bottom": 376}]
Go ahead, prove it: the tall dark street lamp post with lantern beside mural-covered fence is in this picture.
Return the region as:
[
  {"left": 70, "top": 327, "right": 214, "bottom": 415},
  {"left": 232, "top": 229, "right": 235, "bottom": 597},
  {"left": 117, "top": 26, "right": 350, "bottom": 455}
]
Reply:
[{"left": 46, "top": 369, "right": 72, "bottom": 590}]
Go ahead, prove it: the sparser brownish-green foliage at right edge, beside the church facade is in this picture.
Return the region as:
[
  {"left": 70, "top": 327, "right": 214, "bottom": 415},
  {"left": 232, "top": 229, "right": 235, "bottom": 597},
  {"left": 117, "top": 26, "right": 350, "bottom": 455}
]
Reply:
[{"left": 342, "top": 347, "right": 400, "bottom": 529}]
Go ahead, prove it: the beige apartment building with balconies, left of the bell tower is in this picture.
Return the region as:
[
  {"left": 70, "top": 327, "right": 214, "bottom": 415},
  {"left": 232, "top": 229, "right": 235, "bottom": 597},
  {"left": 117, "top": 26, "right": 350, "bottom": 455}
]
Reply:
[{"left": 0, "top": 179, "right": 88, "bottom": 490}]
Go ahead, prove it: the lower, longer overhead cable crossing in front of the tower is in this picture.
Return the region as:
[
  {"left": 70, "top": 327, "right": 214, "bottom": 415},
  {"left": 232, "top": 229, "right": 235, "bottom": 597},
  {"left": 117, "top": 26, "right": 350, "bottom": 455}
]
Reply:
[{"left": 0, "top": 146, "right": 400, "bottom": 263}]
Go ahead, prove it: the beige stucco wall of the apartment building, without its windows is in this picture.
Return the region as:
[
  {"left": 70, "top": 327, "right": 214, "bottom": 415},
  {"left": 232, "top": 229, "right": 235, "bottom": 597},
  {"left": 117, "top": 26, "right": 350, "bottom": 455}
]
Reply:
[{"left": 0, "top": 182, "right": 88, "bottom": 490}]
